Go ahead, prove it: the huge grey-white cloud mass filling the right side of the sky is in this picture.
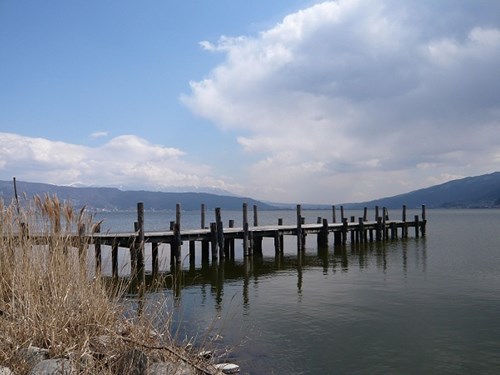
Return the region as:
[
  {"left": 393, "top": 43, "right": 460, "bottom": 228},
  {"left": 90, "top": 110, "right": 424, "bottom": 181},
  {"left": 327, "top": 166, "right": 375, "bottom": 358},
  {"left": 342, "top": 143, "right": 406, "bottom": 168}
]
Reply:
[{"left": 182, "top": 0, "right": 500, "bottom": 202}]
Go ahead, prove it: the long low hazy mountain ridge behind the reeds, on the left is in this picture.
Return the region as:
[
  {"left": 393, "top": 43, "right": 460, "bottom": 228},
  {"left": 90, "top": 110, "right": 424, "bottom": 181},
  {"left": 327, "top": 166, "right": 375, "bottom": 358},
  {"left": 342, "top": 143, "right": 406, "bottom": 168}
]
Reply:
[{"left": 0, "top": 181, "right": 275, "bottom": 211}]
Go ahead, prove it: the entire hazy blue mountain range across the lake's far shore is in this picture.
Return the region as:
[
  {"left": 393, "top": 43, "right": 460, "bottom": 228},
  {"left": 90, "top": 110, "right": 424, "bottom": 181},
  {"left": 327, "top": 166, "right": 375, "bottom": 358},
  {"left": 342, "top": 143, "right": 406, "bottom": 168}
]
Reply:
[{"left": 0, "top": 172, "right": 500, "bottom": 211}]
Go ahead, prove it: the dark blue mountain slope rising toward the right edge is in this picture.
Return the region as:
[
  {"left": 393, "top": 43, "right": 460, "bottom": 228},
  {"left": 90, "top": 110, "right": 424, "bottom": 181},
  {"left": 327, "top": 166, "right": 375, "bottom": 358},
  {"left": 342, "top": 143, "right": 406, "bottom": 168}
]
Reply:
[{"left": 344, "top": 172, "right": 500, "bottom": 209}]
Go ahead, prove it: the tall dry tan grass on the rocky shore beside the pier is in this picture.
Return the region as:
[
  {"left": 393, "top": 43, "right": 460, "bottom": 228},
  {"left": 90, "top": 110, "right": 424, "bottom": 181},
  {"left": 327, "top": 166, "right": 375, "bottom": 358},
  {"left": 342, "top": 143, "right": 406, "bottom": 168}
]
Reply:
[{"left": 0, "top": 196, "right": 213, "bottom": 374}]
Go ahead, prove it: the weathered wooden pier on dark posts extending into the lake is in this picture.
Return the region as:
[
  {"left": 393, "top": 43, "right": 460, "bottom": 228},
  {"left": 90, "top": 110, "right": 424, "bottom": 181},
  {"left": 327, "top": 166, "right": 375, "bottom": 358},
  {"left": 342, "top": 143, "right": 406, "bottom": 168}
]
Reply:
[{"left": 89, "top": 202, "right": 427, "bottom": 276}]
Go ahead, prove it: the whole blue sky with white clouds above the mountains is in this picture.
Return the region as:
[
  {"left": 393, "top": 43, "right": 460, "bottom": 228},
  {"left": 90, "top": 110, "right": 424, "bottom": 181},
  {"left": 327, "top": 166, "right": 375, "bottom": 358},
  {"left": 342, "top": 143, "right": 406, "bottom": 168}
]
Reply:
[{"left": 0, "top": 0, "right": 500, "bottom": 204}]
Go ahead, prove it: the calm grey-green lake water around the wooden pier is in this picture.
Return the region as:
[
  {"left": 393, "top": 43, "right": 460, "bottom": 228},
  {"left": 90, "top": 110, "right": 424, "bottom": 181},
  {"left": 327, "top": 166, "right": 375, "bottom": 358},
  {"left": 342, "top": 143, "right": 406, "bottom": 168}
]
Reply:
[{"left": 94, "top": 210, "right": 500, "bottom": 374}]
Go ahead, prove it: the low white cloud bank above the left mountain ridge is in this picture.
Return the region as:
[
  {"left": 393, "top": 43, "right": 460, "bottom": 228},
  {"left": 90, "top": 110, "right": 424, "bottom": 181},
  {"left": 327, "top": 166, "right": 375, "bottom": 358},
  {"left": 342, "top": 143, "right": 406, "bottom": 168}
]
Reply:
[{"left": 0, "top": 133, "right": 241, "bottom": 191}]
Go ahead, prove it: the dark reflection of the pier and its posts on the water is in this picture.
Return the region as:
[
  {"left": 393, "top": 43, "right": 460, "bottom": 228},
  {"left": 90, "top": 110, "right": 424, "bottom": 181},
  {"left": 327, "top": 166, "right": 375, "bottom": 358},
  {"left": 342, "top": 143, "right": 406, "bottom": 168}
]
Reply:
[{"left": 120, "top": 238, "right": 427, "bottom": 310}]
